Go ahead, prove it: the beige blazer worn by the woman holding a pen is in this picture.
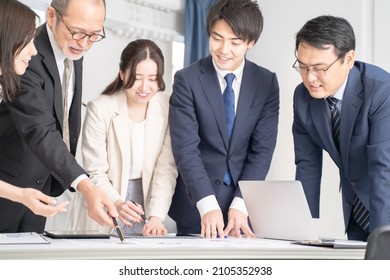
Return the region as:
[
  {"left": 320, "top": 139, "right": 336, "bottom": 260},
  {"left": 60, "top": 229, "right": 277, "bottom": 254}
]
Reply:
[{"left": 67, "top": 91, "right": 177, "bottom": 232}]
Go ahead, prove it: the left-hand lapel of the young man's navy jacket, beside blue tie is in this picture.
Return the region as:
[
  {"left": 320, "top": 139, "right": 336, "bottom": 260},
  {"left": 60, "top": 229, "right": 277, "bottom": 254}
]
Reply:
[{"left": 199, "top": 56, "right": 229, "bottom": 149}]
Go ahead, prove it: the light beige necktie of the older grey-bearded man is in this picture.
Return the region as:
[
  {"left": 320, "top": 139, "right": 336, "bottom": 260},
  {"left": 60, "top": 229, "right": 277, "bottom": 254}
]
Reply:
[{"left": 62, "top": 58, "right": 73, "bottom": 150}]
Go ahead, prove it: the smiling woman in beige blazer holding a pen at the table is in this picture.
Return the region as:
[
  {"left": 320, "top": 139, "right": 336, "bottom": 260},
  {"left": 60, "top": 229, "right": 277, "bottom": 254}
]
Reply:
[{"left": 68, "top": 39, "right": 177, "bottom": 235}]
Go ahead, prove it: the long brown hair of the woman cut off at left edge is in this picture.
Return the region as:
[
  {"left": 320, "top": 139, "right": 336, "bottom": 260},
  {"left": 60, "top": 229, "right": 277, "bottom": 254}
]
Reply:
[{"left": 0, "top": 0, "right": 38, "bottom": 101}]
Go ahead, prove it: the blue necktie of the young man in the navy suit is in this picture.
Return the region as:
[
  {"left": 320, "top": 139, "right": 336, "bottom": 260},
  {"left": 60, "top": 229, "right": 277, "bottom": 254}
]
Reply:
[{"left": 223, "top": 73, "right": 236, "bottom": 186}]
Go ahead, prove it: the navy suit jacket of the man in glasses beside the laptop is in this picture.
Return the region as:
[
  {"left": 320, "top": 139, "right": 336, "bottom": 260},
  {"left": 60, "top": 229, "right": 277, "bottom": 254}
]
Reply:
[{"left": 293, "top": 62, "right": 390, "bottom": 231}]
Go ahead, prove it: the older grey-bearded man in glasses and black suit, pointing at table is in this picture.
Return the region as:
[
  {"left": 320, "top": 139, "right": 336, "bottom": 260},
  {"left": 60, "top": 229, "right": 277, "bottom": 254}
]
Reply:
[{"left": 0, "top": 0, "right": 118, "bottom": 232}]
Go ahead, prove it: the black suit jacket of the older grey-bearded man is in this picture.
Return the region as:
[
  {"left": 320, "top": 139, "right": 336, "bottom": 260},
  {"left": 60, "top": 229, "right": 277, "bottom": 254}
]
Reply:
[{"left": 0, "top": 25, "right": 85, "bottom": 231}]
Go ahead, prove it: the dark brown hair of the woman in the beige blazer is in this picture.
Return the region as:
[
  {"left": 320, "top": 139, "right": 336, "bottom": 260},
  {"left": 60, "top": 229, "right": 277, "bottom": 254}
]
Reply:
[{"left": 102, "top": 39, "right": 165, "bottom": 95}]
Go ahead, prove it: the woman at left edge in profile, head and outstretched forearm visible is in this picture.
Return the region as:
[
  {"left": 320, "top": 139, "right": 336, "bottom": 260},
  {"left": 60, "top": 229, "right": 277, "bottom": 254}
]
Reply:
[{"left": 0, "top": 0, "right": 68, "bottom": 217}]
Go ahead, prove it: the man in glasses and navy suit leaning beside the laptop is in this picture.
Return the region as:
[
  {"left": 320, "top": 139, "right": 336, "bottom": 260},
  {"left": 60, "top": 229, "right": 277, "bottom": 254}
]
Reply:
[{"left": 293, "top": 16, "right": 390, "bottom": 241}]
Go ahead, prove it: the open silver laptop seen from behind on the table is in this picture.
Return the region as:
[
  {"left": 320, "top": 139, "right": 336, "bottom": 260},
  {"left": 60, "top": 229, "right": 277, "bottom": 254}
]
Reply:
[{"left": 238, "top": 181, "right": 318, "bottom": 241}]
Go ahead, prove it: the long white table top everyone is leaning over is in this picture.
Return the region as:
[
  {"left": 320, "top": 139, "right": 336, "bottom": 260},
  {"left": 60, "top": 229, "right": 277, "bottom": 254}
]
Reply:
[{"left": 0, "top": 237, "right": 365, "bottom": 260}]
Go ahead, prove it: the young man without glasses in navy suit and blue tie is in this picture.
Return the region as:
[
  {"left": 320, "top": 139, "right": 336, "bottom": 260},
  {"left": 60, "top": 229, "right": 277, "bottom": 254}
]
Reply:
[{"left": 169, "top": 0, "right": 279, "bottom": 238}]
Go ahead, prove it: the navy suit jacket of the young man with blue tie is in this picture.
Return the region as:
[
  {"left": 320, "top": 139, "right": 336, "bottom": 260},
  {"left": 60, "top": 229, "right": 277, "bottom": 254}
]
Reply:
[{"left": 169, "top": 56, "right": 279, "bottom": 231}]
